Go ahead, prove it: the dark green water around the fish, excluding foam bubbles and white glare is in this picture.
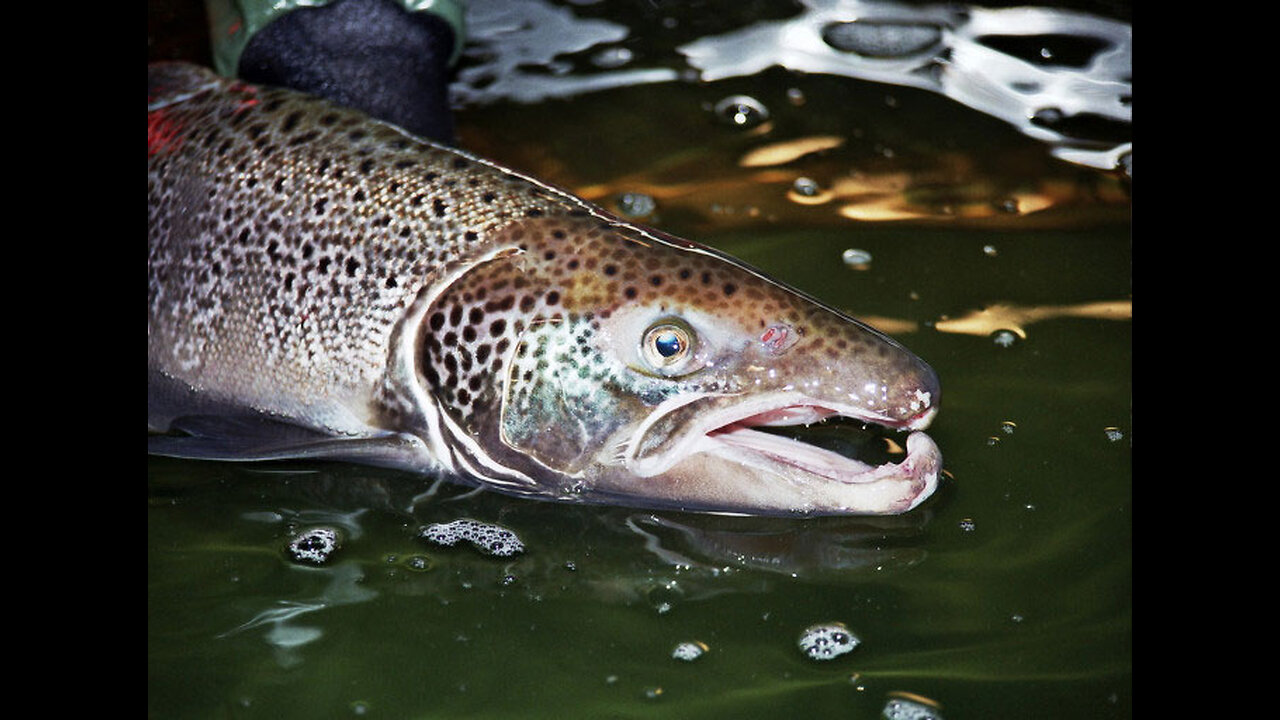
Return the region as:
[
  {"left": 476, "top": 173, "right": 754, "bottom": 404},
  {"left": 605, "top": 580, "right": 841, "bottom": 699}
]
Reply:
[{"left": 147, "top": 2, "right": 1133, "bottom": 720}]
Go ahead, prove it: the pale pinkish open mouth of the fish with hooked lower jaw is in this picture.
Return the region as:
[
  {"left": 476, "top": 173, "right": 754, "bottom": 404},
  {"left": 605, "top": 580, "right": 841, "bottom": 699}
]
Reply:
[{"left": 632, "top": 396, "right": 942, "bottom": 515}]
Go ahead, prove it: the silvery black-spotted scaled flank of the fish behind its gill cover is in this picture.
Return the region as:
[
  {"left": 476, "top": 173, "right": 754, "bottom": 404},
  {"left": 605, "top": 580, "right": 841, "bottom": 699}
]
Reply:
[{"left": 148, "top": 67, "right": 577, "bottom": 430}]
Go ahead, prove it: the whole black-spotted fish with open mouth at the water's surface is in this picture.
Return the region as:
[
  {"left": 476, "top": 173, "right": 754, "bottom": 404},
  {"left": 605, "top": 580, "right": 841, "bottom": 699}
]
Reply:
[{"left": 147, "top": 63, "right": 941, "bottom": 515}]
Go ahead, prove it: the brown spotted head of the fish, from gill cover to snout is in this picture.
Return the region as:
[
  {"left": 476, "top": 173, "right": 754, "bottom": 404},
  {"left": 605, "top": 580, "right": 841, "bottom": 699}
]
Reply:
[{"left": 419, "top": 218, "right": 941, "bottom": 515}]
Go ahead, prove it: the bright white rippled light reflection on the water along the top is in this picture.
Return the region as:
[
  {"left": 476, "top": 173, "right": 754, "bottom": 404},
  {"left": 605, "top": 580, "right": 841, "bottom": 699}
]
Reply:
[{"left": 453, "top": 0, "right": 1133, "bottom": 172}]
